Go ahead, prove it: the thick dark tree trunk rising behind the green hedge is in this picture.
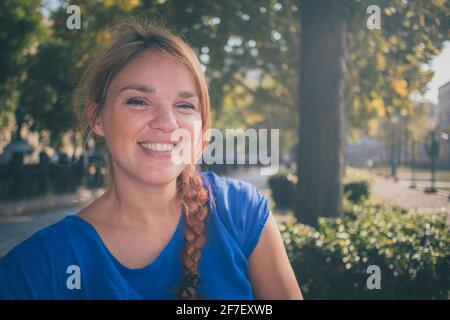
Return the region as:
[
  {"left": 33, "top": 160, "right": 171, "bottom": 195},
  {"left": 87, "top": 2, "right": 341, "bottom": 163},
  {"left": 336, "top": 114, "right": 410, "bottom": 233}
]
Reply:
[{"left": 296, "top": 0, "right": 347, "bottom": 226}]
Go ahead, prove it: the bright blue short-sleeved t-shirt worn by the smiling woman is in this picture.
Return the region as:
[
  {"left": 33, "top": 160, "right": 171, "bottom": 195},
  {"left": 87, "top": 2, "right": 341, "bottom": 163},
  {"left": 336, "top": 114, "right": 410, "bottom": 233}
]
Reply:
[{"left": 0, "top": 172, "right": 270, "bottom": 300}]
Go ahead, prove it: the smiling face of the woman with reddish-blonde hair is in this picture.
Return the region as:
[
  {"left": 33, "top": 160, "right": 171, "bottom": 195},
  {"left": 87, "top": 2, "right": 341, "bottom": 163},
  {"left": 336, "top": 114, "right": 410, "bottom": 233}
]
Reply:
[{"left": 93, "top": 51, "right": 201, "bottom": 185}]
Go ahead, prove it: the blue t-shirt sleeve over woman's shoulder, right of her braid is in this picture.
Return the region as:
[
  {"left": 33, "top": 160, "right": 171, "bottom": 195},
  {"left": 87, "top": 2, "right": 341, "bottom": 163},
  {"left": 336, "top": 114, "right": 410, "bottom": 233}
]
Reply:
[{"left": 202, "top": 172, "right": 270, "bottom": 257}]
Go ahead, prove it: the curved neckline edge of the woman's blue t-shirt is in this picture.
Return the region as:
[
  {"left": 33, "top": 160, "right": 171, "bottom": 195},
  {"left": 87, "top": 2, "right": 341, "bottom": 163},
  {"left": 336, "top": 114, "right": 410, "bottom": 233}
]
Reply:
[{"left": 66, "top": 209, "right": 184, "bottom": 273}]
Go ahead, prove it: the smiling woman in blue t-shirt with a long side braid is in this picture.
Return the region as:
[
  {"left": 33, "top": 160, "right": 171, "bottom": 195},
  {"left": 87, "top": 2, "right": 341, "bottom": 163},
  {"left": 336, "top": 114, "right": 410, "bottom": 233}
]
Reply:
[{"left": 0, "top": 16, "right": 302, "bottom": 299}]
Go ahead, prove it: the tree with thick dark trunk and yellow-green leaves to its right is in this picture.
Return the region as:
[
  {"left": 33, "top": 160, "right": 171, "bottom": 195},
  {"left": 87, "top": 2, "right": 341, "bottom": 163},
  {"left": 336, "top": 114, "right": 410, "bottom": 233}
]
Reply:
[{"left": 297, "top": 0, "right": 450, "bottom": 225}]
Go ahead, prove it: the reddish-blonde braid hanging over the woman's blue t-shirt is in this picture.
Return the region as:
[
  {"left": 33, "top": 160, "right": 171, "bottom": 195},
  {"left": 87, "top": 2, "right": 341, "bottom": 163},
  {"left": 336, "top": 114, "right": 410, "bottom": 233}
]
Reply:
[{"left": 177, "top": 165, "right": 209, "bottom": 300}]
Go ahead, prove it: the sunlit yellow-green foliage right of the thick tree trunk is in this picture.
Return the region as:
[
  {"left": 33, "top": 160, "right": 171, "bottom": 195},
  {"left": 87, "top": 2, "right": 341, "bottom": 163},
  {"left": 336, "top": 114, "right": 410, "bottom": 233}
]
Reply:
[{"left": 347, "top": 0, "right": 450, "bottom": 140}]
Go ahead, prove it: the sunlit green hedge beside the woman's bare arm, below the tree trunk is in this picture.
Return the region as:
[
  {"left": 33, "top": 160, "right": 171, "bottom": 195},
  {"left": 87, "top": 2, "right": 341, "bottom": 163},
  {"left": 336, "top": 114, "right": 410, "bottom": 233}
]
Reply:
[{"left": 280, "top": 203, "right": 450, "bottom": 299}]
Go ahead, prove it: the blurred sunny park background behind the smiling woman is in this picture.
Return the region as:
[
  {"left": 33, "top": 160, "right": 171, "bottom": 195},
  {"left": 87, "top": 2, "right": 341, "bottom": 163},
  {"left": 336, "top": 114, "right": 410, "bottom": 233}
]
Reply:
[{"left": 0, "top": 0, "right": 450, "bottom": 299}]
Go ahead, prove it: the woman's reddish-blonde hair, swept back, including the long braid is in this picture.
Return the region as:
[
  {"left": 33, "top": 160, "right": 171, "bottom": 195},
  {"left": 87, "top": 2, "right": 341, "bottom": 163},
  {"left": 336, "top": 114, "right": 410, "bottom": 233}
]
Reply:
[{"left": 75, "top": 18, "right": 211, "bottom": 299}]
